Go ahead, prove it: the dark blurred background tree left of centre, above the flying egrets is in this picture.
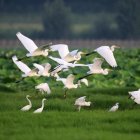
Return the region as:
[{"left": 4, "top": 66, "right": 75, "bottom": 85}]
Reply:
[{"left": 43, "top": 0, "right": 71, "bottom": 39}]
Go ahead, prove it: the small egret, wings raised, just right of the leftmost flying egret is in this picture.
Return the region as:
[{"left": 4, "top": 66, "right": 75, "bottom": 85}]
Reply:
[{"left": 33, "top": 63, "right": 51, "bottom": 77}]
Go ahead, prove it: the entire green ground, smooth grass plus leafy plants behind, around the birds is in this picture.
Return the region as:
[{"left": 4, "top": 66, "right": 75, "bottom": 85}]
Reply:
[{"left": 0, "top": 45, "right": 140, "bottom": 140}]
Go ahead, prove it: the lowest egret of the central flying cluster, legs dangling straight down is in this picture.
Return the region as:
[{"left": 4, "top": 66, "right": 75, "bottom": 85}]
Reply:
[{"left": 56, "top": 74, "right": 79, "bottom": 98}]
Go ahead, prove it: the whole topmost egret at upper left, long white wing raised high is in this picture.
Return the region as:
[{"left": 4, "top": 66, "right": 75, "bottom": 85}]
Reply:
[{"left": 16, "top": 32, "right": 52, "bottom": 57}]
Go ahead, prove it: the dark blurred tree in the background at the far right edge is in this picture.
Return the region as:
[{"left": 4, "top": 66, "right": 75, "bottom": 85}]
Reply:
[{"left": 117, "top": 0, "right": 140, "bottom": 39}]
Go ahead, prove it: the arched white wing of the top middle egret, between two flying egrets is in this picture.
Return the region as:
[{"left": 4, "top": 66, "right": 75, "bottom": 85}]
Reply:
[{"left": 50, "top": 44, "right": 69, "bottom": 58}]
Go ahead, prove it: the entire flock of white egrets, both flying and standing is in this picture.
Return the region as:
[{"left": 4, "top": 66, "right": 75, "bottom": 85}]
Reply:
[{"left": 12, "top": 32, "right": 140, "bottom": 113}]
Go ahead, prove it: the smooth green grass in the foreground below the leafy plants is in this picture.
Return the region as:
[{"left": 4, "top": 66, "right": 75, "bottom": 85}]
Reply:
[{"left": 0, "top": 87, "right": 140, "bottom": 140}]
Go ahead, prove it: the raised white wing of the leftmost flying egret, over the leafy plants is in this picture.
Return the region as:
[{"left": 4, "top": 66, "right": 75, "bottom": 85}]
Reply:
[{"left": 12, "top": 56, "right": 31, "bottom": 73}]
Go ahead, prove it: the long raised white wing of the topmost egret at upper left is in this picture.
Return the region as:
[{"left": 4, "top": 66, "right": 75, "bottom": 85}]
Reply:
[{"left": 16, "top": 32, "right": 38, "bottom": 53}]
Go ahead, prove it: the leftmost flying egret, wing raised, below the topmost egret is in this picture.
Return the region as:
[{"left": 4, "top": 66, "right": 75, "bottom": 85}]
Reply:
[{"left": 12, "top": 56, "right": 38, "bottom": 77}]
